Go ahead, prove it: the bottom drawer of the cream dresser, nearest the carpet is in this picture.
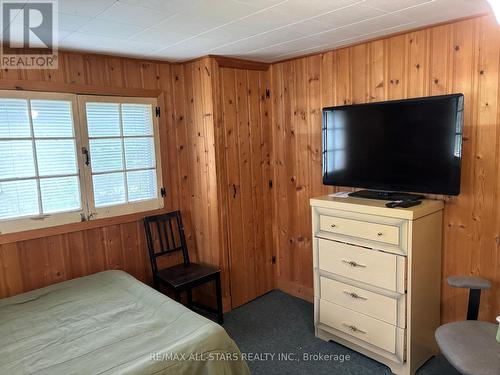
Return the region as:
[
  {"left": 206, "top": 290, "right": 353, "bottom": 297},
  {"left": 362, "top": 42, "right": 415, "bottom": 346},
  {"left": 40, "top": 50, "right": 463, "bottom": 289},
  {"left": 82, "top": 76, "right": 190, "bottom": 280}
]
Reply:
[{"left": 319, "top": 300, "right": 405, "bottom": 354}]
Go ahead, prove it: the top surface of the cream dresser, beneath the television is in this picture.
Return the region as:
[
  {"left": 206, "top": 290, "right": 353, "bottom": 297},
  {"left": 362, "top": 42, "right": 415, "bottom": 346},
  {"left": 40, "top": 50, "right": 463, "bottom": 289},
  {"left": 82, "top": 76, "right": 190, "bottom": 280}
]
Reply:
[{"left": 310, "top": 195, "right": 444, "bottom": 220}]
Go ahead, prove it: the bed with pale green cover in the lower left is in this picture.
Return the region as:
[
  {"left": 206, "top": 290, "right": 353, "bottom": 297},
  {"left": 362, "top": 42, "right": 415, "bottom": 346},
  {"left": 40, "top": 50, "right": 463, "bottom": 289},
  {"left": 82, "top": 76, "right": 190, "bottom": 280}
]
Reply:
[{"left": 0, "top": 271, "right": 249, "bottom": 375}]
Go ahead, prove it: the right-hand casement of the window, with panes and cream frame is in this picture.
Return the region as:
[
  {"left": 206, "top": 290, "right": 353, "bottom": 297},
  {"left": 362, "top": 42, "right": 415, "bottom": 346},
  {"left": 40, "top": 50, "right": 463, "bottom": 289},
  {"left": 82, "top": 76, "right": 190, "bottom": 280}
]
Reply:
[{"left": 78, "top": 96, "right": 163, "bottom": 217}]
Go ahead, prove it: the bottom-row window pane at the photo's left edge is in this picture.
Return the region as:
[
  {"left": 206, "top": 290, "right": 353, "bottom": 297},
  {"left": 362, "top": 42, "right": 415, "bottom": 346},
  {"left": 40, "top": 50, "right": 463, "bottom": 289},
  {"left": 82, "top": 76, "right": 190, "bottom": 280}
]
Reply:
[{"left": 0, "top": 180, "right": 39, "bottom": 220}]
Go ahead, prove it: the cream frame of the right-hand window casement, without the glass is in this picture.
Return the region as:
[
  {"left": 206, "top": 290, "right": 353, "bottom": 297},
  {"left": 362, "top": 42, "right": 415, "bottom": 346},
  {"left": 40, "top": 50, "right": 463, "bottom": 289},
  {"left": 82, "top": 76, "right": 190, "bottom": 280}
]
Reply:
[{"left": 77, "top": 95, "right": 165, "bottom": 220}]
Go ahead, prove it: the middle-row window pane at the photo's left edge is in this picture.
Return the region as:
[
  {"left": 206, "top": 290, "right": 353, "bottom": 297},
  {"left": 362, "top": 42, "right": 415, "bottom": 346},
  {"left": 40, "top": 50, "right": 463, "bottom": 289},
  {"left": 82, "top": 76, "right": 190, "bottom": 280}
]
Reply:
[{"left": 0, "top": 142, "right": 35, "bottom": 180}]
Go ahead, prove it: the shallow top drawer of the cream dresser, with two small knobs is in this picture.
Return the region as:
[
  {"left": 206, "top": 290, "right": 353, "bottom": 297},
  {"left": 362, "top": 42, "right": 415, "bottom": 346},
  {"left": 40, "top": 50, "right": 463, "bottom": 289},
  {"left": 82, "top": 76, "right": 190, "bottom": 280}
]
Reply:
[{"left": 319, "top": 215, "right": 400, "bottom": 245}]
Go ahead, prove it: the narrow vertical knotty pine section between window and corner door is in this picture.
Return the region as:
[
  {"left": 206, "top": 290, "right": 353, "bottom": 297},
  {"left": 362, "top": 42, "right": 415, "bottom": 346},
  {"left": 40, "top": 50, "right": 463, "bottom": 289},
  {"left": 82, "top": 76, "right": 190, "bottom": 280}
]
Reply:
[{"left": 168, "top": 58, "right": 231, "bottom": 310}]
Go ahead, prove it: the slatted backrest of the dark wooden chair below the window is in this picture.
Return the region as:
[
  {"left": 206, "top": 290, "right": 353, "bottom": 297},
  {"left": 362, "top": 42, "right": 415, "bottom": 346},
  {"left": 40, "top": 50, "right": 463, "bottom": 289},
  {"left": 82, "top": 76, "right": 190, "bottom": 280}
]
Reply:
[{"left": 144, "top": 211, "right": 189, "bottom": 273}]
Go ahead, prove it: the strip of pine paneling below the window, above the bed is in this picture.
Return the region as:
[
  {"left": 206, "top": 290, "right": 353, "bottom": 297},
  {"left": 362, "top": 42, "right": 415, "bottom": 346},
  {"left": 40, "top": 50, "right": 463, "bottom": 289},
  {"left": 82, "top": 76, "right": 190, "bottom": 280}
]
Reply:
[{"left": 0, "top": 221, "right": 150, "bottom": 298}]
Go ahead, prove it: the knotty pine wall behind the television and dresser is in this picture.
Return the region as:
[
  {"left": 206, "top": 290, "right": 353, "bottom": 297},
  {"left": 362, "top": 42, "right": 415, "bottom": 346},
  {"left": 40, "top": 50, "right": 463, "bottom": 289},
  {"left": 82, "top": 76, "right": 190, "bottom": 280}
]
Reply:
[{"left": 272, "top": 16, "right": 500, "bottom": 322}]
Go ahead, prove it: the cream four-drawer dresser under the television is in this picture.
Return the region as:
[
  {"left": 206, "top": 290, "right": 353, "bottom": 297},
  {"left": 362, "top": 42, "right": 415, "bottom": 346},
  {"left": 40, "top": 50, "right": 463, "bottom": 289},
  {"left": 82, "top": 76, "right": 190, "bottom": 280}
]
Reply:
[{"left": 311, "top": 196, "right": 443, "bottom": 374}]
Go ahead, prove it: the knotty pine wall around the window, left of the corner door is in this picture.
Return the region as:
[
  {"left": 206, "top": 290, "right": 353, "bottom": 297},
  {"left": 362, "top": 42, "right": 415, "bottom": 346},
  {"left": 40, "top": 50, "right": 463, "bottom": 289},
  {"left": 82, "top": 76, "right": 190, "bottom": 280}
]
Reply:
[{"left": 0, "top": 52, "right": 230, "bottom": 306}]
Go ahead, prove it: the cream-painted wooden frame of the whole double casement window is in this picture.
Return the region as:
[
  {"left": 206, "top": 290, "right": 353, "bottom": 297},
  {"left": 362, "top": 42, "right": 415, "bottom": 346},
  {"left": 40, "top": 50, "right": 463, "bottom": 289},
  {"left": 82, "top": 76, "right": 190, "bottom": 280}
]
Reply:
[{"left": 0, "top": 89, "right": 165, "bottom": 236}]
